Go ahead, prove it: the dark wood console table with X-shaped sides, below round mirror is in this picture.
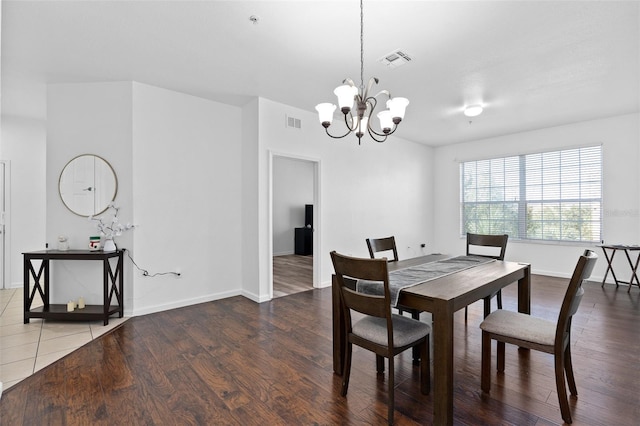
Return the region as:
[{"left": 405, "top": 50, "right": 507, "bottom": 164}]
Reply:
[{"left": 22, "top": 250, "right": 124, "bottom": 325}]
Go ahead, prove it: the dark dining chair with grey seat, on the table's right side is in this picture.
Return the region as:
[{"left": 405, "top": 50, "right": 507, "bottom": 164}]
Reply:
[{"left": 480, "top": 250, "right": 598, "bottom": 423}]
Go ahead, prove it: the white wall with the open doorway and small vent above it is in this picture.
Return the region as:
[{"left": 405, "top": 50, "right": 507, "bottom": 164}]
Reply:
[{"left": 258, "top": 98, "right": 434, "bottom": 300}]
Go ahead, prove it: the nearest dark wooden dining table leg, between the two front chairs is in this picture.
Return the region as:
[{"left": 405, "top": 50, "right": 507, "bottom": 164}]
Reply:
[{"left": 432, "top": 299, "right": 454, "bottom": 425}]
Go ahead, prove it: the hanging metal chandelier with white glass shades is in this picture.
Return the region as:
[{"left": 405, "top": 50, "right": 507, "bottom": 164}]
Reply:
[{"left": 316, "top": 0, "right": 409, "bottom": 145}]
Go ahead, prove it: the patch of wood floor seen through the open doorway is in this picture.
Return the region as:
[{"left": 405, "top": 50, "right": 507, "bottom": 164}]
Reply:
[{"left": 273, "top": 254, "right": 313, "bottom": 298}]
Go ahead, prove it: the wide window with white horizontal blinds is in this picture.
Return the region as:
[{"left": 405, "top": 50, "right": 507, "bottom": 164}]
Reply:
[{"left": 460, "top": 145, "right": 602, "bottom": 242}]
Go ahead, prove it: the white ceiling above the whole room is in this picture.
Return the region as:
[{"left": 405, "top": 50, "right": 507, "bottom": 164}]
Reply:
[{"left": 1, "top": 0, "right": 640, "bottom": 146}]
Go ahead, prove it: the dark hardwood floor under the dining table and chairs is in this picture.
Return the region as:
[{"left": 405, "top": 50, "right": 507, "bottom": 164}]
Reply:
[{"left": 0, "top": 276, "right": 640, "bottom": 426}]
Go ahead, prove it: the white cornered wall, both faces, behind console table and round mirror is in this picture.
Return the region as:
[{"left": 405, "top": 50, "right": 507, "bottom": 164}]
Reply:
[{"left": 46, "top": 82, "right": 242, "bottom": 315}]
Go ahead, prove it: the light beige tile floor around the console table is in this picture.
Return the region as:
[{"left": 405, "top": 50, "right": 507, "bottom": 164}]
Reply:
[{"left": 0, "top": 288, "right": 127, "bottom": 395}]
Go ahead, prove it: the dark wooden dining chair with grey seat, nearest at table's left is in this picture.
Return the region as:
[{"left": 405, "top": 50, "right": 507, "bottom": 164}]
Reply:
[{"left": 331, "top": 251, "right": 431, "bottom": 424}]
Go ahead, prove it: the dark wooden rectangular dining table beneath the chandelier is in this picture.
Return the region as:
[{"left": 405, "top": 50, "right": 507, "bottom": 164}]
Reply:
[{"left": 332, "top": 254, "right": 531, "bottom": 425}]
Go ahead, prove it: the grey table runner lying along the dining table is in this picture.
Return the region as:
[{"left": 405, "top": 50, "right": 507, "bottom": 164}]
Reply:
[{"left": 356, "top": 256, "right": 495, "bottom": 306}]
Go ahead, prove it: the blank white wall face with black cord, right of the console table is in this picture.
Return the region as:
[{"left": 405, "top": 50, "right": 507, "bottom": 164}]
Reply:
[{"left": 133, "top": 83, "right": 242, "bottom": 314}]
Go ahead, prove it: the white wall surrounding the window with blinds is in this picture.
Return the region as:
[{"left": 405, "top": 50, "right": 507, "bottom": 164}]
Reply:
[{"left": 433, "top": 114, "right": 640, "bottom": 280}]
